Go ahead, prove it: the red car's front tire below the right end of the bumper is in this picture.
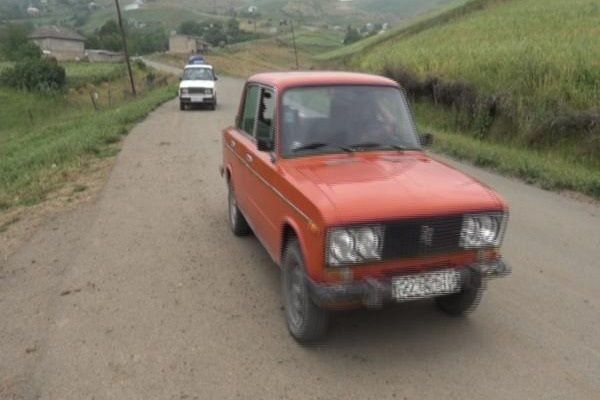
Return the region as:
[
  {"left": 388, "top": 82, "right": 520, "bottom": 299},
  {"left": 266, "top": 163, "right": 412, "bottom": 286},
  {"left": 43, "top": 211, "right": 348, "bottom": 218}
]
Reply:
[{"left": 435, "top": 270, "right": 483, "bottom": 317}]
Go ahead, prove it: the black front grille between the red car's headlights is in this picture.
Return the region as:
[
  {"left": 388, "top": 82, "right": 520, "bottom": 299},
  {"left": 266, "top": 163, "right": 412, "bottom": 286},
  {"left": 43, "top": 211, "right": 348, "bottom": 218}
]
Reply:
[{"left": 382, "top": 215, "right": 462, "bottom": 260}]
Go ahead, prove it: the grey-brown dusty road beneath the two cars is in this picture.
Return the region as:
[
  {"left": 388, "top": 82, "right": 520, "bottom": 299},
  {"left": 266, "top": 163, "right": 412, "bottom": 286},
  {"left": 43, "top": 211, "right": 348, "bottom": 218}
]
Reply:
[{"left": 0, "top": 70, "right": 600, "bottom": 400}]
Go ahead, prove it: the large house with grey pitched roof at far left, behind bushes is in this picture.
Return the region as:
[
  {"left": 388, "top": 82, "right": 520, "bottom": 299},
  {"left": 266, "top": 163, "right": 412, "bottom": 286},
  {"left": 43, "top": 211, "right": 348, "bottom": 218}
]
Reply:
[{"left": 29, "top": 26, "right": 85, "bottom": 61}]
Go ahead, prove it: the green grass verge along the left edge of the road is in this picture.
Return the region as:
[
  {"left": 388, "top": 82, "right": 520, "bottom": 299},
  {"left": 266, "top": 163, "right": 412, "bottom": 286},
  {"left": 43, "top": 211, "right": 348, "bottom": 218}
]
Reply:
[{"left": 0, "top": 85, "right": 176, "bottom": 210}]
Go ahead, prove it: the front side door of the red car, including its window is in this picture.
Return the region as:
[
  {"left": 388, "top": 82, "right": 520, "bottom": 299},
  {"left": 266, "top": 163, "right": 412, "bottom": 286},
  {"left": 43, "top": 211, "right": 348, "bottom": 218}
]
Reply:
[{"left": 237, "top": 86, "right": 284, "bottom": 255}]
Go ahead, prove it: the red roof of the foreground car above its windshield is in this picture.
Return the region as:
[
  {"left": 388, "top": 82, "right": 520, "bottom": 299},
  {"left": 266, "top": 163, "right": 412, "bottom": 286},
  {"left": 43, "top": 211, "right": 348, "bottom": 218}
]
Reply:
[{"left": 248, "top": 71, "right": 400, "bottom": 90}]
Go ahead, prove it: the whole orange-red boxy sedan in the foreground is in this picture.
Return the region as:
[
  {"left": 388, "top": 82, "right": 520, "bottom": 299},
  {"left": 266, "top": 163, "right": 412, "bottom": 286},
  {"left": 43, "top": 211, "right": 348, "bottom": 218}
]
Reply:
[{"left": 221, "top": 72, "right": 509, "bottom": 342}]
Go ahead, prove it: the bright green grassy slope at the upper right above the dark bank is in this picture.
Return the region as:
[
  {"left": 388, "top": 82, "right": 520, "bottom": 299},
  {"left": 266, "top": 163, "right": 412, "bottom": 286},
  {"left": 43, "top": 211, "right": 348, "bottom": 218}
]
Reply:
[{"left": 355, "top": 0, "right": 600, "bottom": 109}]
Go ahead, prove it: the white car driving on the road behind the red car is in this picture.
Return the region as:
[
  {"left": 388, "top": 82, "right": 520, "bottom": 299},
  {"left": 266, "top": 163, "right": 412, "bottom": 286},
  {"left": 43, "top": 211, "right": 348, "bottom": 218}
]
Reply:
[{"left": 179, "top": 64, "right": 217, "bottom": 110}]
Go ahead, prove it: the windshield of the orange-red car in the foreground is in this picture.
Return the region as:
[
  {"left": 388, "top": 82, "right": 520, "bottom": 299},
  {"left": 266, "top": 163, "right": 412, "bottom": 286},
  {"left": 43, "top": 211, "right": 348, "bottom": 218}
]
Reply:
[{"left": 281, "top": 86, "right": 420, "bottom": 157}]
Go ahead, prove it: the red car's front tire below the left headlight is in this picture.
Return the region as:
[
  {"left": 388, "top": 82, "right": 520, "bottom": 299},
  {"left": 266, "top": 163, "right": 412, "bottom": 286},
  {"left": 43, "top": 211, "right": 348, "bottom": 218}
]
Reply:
[{"left": 281, "top": 239, "right": 329, "bottom": 343}]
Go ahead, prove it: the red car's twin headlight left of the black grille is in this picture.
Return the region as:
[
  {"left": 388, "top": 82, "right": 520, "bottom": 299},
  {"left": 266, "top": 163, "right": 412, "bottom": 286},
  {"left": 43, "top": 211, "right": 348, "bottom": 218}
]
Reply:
[{"left": 327, "top": 226, "right": 383, "bottom": 266}]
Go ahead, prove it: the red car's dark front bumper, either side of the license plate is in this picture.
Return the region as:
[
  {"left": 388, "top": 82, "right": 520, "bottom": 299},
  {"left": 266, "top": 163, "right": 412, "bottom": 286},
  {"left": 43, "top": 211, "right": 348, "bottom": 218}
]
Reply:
[{"left": 307, "top": 259, "right": 511, "bottom": 308}]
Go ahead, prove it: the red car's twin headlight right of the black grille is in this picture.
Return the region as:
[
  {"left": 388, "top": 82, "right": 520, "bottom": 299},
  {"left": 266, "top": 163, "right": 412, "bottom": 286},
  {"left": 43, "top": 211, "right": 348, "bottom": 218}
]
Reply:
[{"left": 460, "top": 213, "right": 507, "bottom": 249}]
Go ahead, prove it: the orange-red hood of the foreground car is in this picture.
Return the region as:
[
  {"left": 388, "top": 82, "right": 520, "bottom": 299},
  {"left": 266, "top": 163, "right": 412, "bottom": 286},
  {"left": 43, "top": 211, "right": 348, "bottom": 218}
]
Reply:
[{"left": 288, "top": 152, "right": 505, "bottom": 223}]
